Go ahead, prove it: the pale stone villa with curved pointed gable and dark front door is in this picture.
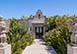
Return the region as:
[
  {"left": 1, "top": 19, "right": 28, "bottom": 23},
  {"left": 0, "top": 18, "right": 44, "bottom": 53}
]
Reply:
[{"left": 19, "top": 9, "right": 48, "bottom": 38}]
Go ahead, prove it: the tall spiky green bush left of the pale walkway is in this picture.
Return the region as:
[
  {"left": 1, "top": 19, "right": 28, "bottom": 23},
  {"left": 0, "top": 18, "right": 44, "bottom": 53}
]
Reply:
[{"left": 7, "top": 19, "right": 35, "bottom": 54}]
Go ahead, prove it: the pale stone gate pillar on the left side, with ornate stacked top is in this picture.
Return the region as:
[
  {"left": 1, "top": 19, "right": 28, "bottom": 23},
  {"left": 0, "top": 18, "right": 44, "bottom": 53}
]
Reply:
[{"left": 0, "top": 18, "right": 11, "bottom": 54}]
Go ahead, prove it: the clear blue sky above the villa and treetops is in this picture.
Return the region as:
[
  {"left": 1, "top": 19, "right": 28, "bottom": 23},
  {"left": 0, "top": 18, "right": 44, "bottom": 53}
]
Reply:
[{"left": 0, "top": 0, "right": 77, "bottom": 18}]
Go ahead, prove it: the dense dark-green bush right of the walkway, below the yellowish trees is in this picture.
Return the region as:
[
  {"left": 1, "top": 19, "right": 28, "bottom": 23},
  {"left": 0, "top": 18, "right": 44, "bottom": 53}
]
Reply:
[{"left": 43, "top": 27, "right": 70, "bottom": 54}]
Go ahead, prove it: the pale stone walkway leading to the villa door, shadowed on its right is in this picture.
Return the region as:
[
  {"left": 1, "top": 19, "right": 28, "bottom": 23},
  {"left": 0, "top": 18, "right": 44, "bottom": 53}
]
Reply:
[{"left": 22, "top": 39, "right": 56, "bottom": 54}]
